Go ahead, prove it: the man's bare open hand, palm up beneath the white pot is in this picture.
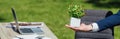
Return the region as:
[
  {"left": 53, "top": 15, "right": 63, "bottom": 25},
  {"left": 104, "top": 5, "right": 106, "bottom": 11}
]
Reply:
[{"left": 65, "top": 23, "right": 92, "bottom": 32}]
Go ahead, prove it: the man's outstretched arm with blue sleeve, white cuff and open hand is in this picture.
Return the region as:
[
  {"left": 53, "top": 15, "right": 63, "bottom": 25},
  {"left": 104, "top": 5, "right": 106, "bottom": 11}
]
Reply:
[{"left": 67, "top": 10, "right": 120, "bottom": 31}]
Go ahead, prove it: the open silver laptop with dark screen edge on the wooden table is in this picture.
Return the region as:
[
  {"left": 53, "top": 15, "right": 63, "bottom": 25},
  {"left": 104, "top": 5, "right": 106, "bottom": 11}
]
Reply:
[{"left": 11, "top": 8, "right": 44, "bottom": 35}]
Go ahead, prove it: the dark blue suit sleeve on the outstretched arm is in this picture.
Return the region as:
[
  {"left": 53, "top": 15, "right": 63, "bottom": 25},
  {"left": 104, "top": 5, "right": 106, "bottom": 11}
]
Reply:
[{"left": 96, "top": 10, "right": 120, "bottom": 30}]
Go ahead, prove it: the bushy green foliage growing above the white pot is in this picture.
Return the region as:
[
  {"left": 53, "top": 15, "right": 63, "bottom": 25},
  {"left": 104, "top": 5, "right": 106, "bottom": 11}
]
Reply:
[{"left": 68, "top": 5, "right": 85, "bottom": 18}]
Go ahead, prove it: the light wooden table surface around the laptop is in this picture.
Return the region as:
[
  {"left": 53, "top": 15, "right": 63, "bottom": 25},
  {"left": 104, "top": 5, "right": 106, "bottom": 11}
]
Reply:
[{"left": 0, "top": 22, "right": 58, "bottom": 39}]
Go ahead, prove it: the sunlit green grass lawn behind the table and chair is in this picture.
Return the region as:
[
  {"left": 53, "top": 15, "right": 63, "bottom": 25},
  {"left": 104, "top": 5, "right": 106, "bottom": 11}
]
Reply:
[{"left": 0, "top": 0, "right": 120, "bottom": 39}]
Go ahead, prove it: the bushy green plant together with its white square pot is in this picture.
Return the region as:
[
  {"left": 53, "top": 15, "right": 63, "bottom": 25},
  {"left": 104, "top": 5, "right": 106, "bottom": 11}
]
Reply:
[{"left": 68, "top": 5, "right": 85, "bottom": 27}]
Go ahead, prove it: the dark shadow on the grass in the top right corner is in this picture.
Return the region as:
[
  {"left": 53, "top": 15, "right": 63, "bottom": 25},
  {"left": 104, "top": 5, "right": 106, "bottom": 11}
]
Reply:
[{"left": 85, "top": 0, "right": 120, "bottom": 8}]
